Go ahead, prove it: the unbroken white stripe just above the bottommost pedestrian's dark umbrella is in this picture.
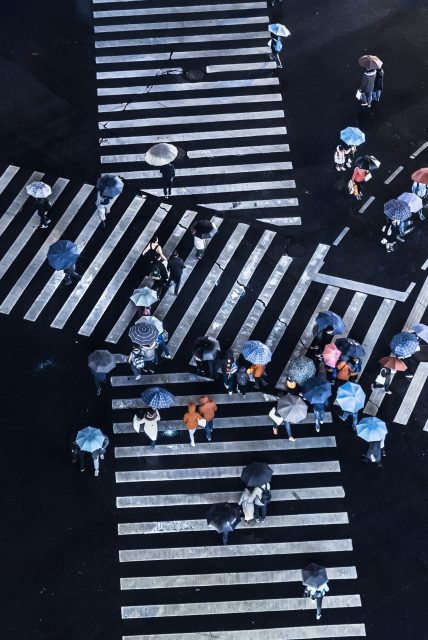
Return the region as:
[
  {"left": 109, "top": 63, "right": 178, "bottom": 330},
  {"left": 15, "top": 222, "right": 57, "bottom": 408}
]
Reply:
[{"left": 119, "top": 531, "right": 352, "bottom": 562}]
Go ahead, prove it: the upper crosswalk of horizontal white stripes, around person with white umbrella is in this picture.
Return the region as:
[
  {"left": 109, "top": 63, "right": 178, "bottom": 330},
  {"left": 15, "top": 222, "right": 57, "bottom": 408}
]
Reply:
[{"left": 93, "top": 0, "right": 300, "bottom": 219}]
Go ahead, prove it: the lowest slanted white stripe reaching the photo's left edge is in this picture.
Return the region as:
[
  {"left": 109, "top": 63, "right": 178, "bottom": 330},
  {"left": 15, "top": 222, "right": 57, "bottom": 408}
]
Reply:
[{"left": 0, "top": 184, "right": 93, "bottom": 313}]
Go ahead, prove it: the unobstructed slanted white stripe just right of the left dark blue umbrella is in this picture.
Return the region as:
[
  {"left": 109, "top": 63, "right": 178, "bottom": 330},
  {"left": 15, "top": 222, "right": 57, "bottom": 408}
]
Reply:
[{"left": 50, "top": 196, "right": 145, "bottom": 329}]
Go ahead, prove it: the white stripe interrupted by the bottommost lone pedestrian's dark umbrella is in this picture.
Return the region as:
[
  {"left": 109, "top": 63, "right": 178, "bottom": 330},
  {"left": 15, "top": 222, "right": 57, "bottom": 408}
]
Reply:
[{"left": 120, "top": 566, "right": 357, "bottom": 591}]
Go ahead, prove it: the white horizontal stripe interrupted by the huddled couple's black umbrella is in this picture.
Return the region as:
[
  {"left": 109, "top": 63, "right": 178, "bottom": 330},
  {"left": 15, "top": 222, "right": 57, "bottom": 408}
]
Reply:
[{"left": 115, "top": 462, "right": 340, "bottom": 483}]
